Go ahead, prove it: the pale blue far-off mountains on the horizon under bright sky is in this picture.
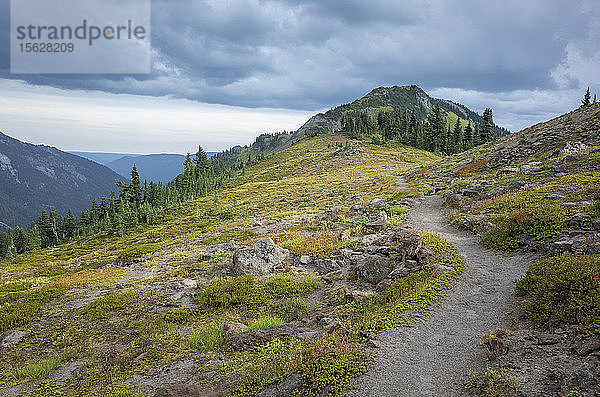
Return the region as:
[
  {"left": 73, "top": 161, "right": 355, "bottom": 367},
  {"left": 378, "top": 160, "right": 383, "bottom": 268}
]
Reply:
[{"left": 70, "top": 152, "right": 216, "bottom": 183}]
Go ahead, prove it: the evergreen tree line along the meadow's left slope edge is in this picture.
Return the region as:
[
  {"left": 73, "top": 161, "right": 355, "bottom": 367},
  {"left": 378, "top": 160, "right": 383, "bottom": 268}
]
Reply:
[{"left": 0, "top": 147, "right": 248, "bottom": 259}]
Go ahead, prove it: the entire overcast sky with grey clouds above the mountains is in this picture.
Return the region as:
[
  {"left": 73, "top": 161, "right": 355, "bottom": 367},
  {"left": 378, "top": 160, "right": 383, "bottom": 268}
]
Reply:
[{"left": 0, "top": 0, "right": 600, "bottom": 153}]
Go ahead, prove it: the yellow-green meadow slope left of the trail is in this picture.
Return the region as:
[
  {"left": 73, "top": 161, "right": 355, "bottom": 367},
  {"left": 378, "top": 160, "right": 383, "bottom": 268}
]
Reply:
[{"left": 0, "top": 135, "right": 454, "bottom": 396}]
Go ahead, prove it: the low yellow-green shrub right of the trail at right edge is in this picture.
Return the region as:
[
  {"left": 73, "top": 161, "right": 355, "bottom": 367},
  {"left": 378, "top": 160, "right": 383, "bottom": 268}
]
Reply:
[{"left": 517, "top": 255, "right": 600, "bottom": 333}]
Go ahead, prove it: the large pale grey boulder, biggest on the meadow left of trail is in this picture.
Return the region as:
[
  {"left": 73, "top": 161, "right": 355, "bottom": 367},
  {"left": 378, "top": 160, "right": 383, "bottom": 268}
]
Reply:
[{"left": 232, "top": 237, "right": 290, "bottom": 276}]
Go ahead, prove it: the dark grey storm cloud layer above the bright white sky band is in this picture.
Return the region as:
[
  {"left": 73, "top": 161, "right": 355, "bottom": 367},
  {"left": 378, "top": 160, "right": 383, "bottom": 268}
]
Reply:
[{"left": 0, "top": 0, "right": 600, "bottom": 109}]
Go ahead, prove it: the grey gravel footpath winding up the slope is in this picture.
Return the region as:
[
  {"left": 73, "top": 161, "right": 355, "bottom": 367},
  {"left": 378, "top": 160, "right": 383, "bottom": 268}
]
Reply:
[{"left": 347, "top": 196, "right": 533, "bottom": 396}]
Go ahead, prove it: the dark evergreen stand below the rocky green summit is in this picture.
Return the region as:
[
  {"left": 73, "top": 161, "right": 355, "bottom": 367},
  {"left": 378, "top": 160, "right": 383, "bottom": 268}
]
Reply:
[{"left": 342, "top": 103, "right": 498, "bottom": 154}]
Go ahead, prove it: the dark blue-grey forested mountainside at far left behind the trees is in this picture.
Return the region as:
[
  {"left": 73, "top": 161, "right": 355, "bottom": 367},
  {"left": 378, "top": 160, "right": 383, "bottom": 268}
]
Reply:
[{"left": 0, "top": 133, "right": 125, "bottom": 229}]
